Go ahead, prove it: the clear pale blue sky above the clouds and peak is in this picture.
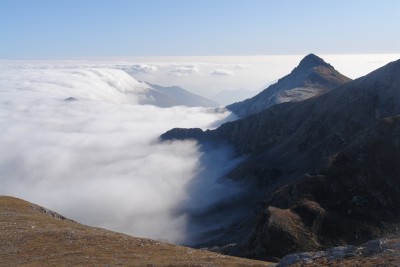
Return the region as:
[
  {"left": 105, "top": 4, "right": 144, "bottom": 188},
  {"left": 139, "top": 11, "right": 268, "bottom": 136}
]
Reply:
[{"left": 0, "top": 0, "right": 400, "bottom": 59}]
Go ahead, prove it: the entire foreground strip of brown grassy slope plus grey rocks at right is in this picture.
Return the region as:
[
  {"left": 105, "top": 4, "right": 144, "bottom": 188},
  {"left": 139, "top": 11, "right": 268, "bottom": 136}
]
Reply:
[{"left": 0, "top": 196, "right": 400, "bottom": 267}]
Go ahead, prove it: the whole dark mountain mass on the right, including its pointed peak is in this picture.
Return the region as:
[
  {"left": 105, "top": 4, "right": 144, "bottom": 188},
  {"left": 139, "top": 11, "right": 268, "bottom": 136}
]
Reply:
[{"left": 161, "top": 55, "right": 400, "bottom": 259}]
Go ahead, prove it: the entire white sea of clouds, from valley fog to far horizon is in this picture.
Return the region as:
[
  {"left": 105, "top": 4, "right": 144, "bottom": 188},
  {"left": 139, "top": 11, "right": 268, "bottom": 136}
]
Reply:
[{"left": 0, "top": 54, "right": 400, "bottom": 243}]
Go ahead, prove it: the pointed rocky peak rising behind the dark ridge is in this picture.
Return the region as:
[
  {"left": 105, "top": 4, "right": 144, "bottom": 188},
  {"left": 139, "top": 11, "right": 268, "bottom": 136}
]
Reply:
[{"left": 227, "top": 54, "right": 350, "bottom": 117}]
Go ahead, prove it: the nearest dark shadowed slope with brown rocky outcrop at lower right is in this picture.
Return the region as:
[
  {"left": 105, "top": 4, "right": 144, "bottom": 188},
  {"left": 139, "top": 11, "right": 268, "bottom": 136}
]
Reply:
[{"left": 248, "top": 116, "right": 400, "bottom": 256}]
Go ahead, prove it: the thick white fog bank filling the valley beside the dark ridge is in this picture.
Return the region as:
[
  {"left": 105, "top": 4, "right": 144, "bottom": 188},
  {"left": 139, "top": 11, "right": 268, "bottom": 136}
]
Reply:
[{"left": 0, "top": 65, "right": 241, "bottom": 243}]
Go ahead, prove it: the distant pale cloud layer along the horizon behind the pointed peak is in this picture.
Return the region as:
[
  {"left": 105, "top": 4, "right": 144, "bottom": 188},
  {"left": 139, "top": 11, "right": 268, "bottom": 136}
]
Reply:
[{"left": 0, "top": 54, "right": 400, "bottom": 104}]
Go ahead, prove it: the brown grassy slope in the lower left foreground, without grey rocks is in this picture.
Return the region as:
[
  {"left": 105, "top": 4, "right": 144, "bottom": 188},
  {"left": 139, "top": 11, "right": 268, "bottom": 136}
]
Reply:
[{"left": 0, "top": 196, "right": 270, "bottom": 266}]
